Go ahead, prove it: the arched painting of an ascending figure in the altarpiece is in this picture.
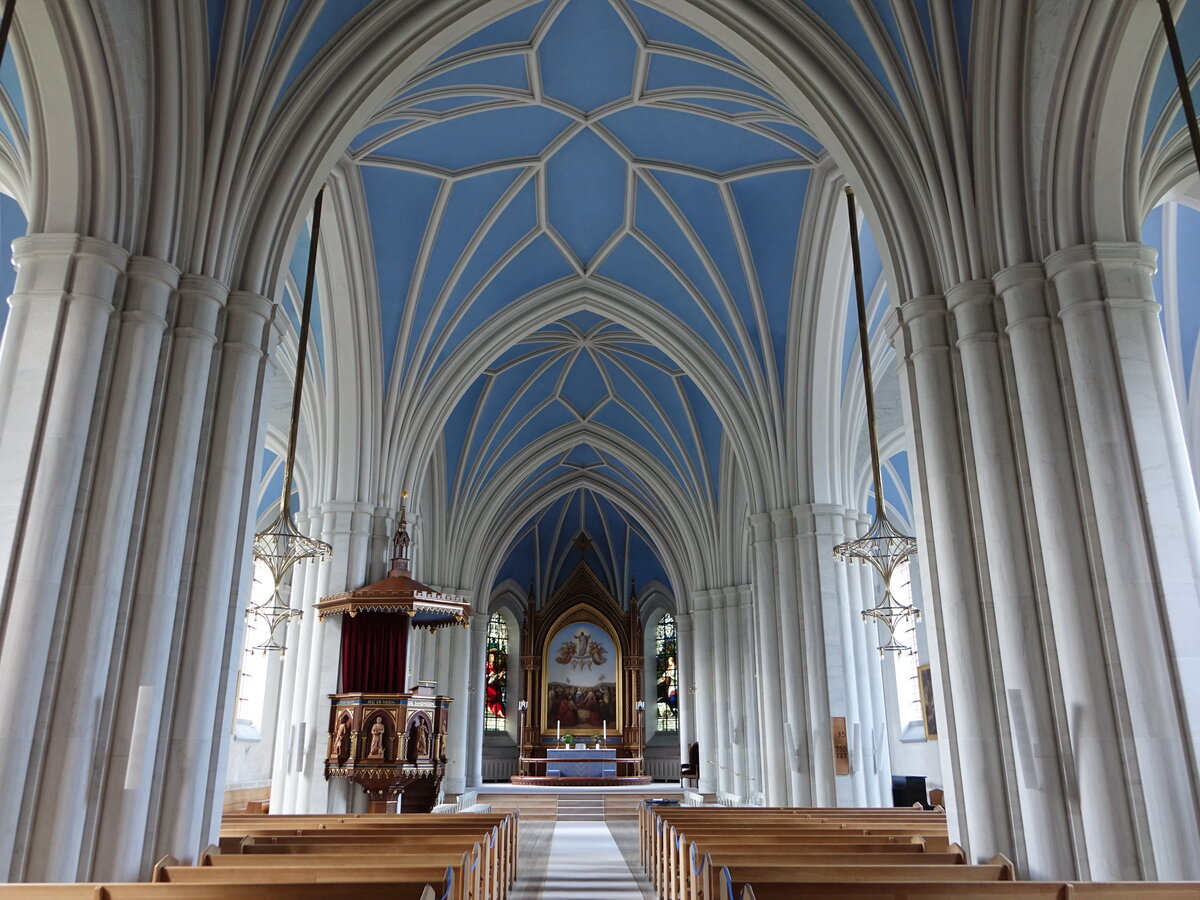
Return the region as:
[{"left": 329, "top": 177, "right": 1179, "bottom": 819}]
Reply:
[{"left": 545, "top": 622, "right": 617, "bottom": 734}]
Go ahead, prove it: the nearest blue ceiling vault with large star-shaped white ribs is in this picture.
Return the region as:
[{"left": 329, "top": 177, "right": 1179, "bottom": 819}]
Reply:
[{"left": 352, "top": 0, "right": 822, "bottom": 391}]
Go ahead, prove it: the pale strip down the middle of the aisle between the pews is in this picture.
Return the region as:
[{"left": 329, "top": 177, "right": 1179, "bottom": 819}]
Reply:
[{"left": 512, "top": 822, "right": 646, "bottom": 900}]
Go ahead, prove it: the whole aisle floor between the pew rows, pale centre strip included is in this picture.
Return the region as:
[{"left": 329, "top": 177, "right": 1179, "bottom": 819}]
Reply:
[{"left": 511, "top": 822, "right": 654, "bottom": 900}]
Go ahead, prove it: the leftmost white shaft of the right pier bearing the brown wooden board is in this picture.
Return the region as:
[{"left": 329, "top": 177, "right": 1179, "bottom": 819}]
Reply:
[{"left": 750, "top": 512, "right": 792, "bottom": 806}]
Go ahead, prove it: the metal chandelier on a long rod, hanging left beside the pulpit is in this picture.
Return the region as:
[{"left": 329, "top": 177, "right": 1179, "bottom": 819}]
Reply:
[{"left": 246, "top": 185, "right": 334, "bottom": 654}]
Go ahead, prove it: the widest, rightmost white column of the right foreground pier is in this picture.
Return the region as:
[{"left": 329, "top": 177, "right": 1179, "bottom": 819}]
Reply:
[{"left": 1046, "top": 244, "right": 1200, "bottom": 880}]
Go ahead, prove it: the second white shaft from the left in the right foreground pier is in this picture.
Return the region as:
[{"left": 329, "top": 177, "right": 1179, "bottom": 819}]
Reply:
[{"left": 947, "top": 281, "right": 1079, "bottom": 878}]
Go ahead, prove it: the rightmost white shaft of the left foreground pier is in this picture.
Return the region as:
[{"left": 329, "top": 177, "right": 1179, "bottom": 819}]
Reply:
[{"left": 156, "top": 293, "right": 274, "bottom": 862}]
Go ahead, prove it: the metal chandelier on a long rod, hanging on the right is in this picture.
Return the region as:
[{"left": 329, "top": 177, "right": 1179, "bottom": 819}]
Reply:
[{"left": 833, "top": 187, "right": 920, "bottom": 655}]
